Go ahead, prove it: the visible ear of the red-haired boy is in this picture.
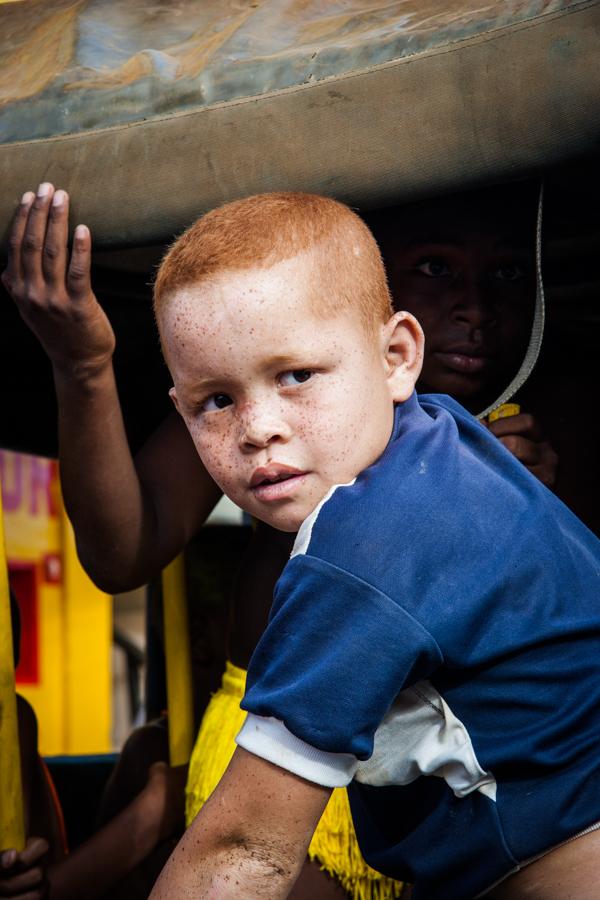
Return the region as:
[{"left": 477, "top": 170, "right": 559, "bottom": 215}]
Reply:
[{"left": 382, "top": 312, "right": 425, "bottom": 403}]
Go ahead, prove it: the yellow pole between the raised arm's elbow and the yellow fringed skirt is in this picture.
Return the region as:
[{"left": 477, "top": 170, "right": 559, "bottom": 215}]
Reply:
[{"left": 162, "top": 554, "right": 194, "bottom": 766}]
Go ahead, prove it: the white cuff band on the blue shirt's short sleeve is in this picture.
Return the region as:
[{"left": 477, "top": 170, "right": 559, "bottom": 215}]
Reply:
[{"left": 235, "top": 713, "right": 358, "bottom": 787}]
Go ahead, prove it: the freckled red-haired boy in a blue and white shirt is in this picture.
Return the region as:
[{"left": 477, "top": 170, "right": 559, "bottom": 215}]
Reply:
[{"left": 153, "top": 194, "right": 600, "bottom": 900}]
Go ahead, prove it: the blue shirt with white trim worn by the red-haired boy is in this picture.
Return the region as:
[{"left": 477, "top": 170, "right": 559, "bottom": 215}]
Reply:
[{"left": 238, "top": 395, "right": 600, "bottom": 900}]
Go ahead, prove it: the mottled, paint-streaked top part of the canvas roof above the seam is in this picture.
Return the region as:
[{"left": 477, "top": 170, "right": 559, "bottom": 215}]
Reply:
[{"left": 0, "top": 0, "right": 578, "bottom": 142}]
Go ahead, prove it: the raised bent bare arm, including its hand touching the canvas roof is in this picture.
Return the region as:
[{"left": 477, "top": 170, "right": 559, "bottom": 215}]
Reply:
[{"left": 2, "top": 185, "right": 220, "bottom": 591}]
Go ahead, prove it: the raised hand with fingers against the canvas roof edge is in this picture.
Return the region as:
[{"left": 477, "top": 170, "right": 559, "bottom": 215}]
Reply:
[{"left": 2, "top": 183, "right": 115, "bottom": 377}]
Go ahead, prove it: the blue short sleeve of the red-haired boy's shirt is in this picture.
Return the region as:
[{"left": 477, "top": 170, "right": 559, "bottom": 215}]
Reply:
[{"left": 242, "top": 555, "right": 442, "bottom": 781}]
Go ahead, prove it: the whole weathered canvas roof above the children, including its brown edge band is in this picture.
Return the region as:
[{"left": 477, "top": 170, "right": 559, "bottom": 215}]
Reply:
[{"left": 0, "top": 0, "right": 600, "bottom": 246}]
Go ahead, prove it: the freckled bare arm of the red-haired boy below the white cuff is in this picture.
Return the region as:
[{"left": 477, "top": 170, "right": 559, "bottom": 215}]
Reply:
[{"left": 151, "top": 747, "right": 331, "bottom": 900}]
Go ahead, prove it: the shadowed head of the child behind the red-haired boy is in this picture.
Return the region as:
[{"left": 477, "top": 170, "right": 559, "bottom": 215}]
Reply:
[{"left": 377, "top": 199, "right": 535, "bottom": 413}]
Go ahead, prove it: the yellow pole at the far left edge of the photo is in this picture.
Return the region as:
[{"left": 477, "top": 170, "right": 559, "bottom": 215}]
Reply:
[{"left": 0, "top": 478, "right": 25, "bottom": 850}]
